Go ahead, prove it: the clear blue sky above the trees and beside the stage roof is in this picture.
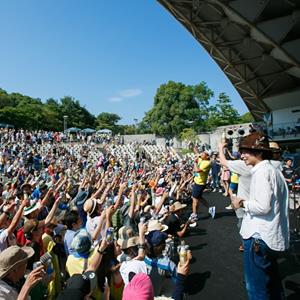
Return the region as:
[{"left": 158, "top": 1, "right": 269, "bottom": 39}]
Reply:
[{"left": 0, "top": 0, "right": 247, "bottom": 124}]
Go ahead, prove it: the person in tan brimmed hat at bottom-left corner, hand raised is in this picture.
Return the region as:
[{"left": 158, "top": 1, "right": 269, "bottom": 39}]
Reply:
[{"left": 0, "top": 246, "right": 45, "bottom": 300}]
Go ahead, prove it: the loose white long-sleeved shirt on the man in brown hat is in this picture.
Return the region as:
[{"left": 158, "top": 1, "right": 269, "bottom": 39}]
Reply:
[{"left": 240, "top": 160, "right": 289, "bottom": 251}]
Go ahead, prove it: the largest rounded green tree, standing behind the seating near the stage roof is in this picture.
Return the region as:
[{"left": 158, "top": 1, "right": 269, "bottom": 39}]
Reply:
[{"left": 141, "top": 81, "right": 213, "bottom": 137}]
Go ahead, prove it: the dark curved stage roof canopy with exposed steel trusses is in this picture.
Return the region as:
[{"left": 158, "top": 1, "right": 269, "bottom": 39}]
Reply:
[{"left": 158, "top": 0, "right": 300, "bottom": 119}]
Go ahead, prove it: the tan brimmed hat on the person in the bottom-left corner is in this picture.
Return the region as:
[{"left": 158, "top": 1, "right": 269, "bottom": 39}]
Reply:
[{"left": 0, "top": 246, "right": 34, "bottom": 279}]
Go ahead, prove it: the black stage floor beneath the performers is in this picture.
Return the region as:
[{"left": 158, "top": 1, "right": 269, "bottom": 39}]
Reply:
[{"left": 185, "top": 193, "right": 300, "bottom": 300}]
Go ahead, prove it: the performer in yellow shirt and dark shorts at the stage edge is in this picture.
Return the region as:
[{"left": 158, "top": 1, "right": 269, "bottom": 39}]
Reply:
[{"left": 190, "top": 151, "right": 216, "bottom": 227}]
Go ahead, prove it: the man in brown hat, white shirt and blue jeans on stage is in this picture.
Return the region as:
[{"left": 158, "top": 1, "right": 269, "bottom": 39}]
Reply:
[{"left": 232, "top": 132, "right": 289, "bottom": 299}]
